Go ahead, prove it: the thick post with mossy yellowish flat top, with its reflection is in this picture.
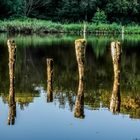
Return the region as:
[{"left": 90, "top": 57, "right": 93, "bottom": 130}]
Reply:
[{"left": 74, "top": 39, "right": 86, "bottom": 118}]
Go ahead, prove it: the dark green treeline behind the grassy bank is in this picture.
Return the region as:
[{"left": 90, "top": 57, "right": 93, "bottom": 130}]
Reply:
[{"left": 0, "top": 0, "right": 140, "bottom": 24}]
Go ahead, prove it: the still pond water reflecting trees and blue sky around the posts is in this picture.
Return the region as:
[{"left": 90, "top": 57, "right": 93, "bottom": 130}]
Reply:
[{"left": 0, "top": 34, "right": 140, "bottom": 140}]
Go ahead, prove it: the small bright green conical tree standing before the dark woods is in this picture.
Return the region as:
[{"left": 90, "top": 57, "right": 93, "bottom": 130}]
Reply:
[{"left": 92, "top": 9, "right": 107, "bottom": 24}]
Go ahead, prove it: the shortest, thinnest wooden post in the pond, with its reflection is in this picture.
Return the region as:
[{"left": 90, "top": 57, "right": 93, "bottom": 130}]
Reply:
[{"left": 47, "top": 58, "right": 53, "bottom": 102}]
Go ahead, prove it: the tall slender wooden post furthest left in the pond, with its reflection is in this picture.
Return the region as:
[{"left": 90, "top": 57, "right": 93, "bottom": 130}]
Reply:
[{"left": 7, "top": 39, "right": 16, "bottom": 125}]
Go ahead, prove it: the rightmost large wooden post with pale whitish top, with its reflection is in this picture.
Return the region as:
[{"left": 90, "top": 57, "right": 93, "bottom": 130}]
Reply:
[{"left": 110, "top": 42, "right": 121, "bottom": 113}]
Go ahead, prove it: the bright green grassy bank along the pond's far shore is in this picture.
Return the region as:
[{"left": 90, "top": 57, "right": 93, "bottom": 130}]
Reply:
[{"left": 0, "top": 19, "right": 140, "bottom": 34}]
